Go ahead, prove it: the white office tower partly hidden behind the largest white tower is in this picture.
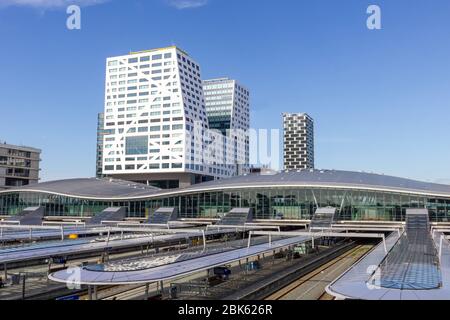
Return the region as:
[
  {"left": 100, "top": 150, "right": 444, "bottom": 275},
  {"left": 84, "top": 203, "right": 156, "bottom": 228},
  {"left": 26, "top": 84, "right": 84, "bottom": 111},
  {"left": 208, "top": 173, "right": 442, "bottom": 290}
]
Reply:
[{"left": 203, "top": 78, "right": 250, "bottom": 175}]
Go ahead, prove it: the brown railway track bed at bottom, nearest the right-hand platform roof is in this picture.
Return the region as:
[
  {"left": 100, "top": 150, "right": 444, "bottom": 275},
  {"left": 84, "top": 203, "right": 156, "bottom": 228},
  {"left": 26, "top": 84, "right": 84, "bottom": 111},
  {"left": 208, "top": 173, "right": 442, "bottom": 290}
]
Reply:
[{"left": 265, "top": 245, "right": 371, "bottom": 300}]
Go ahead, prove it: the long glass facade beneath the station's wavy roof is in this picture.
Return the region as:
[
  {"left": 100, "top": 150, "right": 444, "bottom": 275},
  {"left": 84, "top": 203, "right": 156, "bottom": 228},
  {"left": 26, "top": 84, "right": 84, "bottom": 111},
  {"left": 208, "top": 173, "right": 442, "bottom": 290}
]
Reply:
[{"left": 0, "top": 187, "right": 450, "bottom": 222}]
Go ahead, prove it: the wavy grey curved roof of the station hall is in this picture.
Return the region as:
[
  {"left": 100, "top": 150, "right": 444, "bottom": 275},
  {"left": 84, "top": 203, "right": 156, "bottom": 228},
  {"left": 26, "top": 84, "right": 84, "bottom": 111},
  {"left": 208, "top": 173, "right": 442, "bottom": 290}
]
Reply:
[{"left": 0, "top": 170, "right": 450, "bottom": 200}]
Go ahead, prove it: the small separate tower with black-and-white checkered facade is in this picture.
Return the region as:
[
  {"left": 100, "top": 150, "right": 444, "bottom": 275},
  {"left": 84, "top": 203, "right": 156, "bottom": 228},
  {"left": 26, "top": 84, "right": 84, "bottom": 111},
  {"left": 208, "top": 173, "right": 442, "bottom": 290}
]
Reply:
[{"left": 283, "top": 113, "right": 314, "bottom": 170}]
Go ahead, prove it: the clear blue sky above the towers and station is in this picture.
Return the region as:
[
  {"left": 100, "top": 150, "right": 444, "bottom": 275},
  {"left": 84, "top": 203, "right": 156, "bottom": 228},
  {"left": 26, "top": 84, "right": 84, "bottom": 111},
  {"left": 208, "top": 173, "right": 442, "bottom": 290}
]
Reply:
[{"left": 0, "top": 0, "right": 450, "bottom": 183}]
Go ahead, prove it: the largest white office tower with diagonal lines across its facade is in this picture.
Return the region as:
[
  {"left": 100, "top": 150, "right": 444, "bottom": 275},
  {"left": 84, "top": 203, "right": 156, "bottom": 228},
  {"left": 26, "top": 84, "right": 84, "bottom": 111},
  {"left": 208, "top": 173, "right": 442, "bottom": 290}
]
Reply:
[{"left": 103, "top": 47, "right": 228, "bottom": 188}]
